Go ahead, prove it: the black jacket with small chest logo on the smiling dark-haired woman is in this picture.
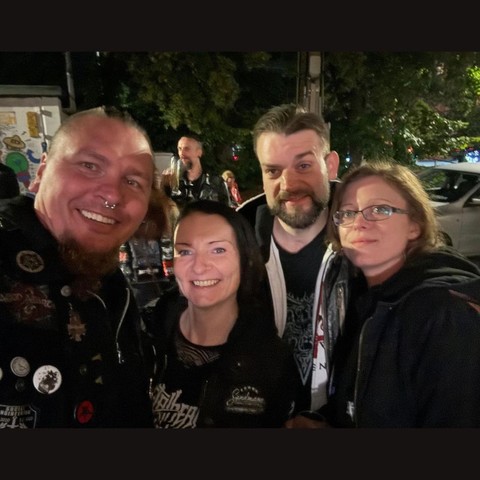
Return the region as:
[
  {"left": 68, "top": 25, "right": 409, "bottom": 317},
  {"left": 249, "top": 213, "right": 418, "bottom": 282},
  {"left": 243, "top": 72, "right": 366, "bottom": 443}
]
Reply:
[{"left": 146, "top": 285, "right": 300, "bottom": 427}]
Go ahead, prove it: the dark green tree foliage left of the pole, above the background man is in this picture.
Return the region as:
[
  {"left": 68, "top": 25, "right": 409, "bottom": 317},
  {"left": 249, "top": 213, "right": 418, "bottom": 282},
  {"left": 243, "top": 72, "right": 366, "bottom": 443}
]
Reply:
[{"left": 96, "top": 52, "right": 296, "bottom": 193}]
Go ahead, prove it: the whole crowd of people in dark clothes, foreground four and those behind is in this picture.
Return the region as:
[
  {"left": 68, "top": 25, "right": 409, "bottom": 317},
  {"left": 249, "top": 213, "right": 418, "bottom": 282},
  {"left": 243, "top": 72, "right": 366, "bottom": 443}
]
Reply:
[{"left": 0, "top": 100, "right": 480, "bottom": 429}]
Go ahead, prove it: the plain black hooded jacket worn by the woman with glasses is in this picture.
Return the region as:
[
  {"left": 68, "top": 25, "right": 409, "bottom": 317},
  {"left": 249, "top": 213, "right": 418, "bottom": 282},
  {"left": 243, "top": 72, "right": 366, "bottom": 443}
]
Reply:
[{"left": 323, "top": 249, "right": 480, "bottom": 428}]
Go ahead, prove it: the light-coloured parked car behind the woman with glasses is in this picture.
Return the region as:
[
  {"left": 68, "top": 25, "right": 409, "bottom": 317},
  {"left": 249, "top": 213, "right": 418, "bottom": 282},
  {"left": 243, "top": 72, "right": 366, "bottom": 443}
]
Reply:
[{"left": 418, "top": 162, "right": 480, "bottom": 257}]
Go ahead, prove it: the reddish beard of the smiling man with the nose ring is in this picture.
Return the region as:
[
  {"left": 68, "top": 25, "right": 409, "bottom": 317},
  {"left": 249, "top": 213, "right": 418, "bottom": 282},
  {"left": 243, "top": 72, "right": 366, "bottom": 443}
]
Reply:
[{"left": 58, "top": 240, "right": 119, "bottom": 299}]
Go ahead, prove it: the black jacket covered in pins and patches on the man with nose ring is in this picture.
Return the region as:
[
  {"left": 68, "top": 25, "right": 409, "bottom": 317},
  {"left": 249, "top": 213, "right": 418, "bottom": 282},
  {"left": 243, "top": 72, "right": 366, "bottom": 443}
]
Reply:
[{"left": 0, "top": 195, "right": 153, "bottom": 428}]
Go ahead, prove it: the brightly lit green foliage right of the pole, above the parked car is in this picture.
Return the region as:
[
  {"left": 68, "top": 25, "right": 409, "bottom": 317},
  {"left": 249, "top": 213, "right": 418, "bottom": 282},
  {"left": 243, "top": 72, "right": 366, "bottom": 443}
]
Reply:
[{"left": 324, "top": 52, "right": 479, "bottom": 172}]
